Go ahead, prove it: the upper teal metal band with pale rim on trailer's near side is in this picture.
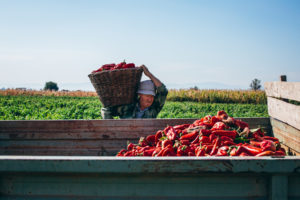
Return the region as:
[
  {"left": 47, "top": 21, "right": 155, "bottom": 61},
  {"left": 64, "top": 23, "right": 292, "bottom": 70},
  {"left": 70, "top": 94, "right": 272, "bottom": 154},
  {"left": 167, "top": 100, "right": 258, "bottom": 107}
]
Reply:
[{"left": 0, "top": 156, "right": 300, "bottom": 174}]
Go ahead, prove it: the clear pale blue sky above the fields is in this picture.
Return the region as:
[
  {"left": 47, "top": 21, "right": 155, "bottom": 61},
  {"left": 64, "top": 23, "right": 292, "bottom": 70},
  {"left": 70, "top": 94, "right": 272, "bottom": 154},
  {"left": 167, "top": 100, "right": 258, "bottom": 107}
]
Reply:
[{"left": 0, "top": 0, "right": 300, "bottom": 90}]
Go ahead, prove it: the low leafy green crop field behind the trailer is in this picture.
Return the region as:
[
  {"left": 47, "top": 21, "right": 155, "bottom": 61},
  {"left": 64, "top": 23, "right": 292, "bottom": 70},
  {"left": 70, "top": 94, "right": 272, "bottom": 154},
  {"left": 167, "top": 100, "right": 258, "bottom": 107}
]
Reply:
[{"left": 0, "top": 95, "right": 268, "bottom": 120}]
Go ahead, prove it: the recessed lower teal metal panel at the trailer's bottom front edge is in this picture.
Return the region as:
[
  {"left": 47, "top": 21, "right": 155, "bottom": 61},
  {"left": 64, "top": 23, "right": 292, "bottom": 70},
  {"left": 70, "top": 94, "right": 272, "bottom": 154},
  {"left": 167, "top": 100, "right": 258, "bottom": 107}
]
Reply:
[{"left": 0, "top": 173, "right": 268, "bottom": 200}]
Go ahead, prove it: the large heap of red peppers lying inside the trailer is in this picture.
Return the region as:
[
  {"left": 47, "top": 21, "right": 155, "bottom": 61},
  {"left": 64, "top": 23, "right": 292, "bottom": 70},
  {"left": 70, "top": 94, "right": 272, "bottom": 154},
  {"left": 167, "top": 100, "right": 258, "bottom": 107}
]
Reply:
[{"left": 117, "top": 111, "right": 286, "bottom": 157}]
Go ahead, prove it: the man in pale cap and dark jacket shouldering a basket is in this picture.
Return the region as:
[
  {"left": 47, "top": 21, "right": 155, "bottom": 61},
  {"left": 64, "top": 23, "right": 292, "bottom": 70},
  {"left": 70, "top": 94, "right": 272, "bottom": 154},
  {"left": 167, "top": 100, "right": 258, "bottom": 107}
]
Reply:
[{"left": 101, "top": 65, "right": 168, "bottom": 119}]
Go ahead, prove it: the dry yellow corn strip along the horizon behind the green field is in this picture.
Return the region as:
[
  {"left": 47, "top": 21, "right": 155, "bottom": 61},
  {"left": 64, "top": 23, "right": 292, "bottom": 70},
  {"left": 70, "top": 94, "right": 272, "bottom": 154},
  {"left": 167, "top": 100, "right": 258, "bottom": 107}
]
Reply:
[{"left": 0, "top": 89, "right": 267, "bottom": 104}]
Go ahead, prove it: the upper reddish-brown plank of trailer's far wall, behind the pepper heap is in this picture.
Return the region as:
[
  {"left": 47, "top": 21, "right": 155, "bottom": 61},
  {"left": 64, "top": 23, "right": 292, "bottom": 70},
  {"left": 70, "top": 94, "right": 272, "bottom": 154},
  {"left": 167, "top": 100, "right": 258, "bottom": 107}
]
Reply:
[{"left": 0, "top": 118, "right": 271, "bottom": 143}]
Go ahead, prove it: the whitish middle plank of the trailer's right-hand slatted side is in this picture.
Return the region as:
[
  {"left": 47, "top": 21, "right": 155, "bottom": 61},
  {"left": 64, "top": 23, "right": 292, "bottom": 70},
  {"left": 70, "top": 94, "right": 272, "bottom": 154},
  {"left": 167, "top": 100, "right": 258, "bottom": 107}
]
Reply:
[{"left": 268, "top": 97, "right": 300, "bottom": 130}]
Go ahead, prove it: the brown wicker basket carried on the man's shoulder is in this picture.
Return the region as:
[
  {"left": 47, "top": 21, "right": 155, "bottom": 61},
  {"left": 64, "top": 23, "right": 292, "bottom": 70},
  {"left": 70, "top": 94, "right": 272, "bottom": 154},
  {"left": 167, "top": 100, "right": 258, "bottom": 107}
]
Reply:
[{"left": 88, "top": 67, "right": 143, "bottom": 107}]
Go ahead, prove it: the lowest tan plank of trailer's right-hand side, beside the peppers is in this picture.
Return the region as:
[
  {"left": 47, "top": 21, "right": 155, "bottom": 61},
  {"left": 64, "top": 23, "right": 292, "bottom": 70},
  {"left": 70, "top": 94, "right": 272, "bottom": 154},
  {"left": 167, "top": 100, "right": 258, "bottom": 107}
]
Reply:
[{"left": 270, "top": 118, "right": 300, "bottom": 153}]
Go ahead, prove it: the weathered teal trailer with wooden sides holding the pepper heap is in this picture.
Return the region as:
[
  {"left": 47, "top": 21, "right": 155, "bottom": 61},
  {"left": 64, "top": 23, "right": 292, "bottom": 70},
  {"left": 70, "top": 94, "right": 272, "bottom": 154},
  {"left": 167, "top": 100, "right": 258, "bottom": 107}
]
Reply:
[{"left": 0, "top": 80, "right": 300, "bottom": 200}]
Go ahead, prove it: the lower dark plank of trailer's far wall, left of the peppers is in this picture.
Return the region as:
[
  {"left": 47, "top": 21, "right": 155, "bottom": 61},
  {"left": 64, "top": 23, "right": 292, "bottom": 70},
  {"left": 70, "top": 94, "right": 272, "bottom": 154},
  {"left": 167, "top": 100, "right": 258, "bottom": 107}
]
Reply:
[{"left": 0, "top": 139, "right": 137, "bottom": 156}]
